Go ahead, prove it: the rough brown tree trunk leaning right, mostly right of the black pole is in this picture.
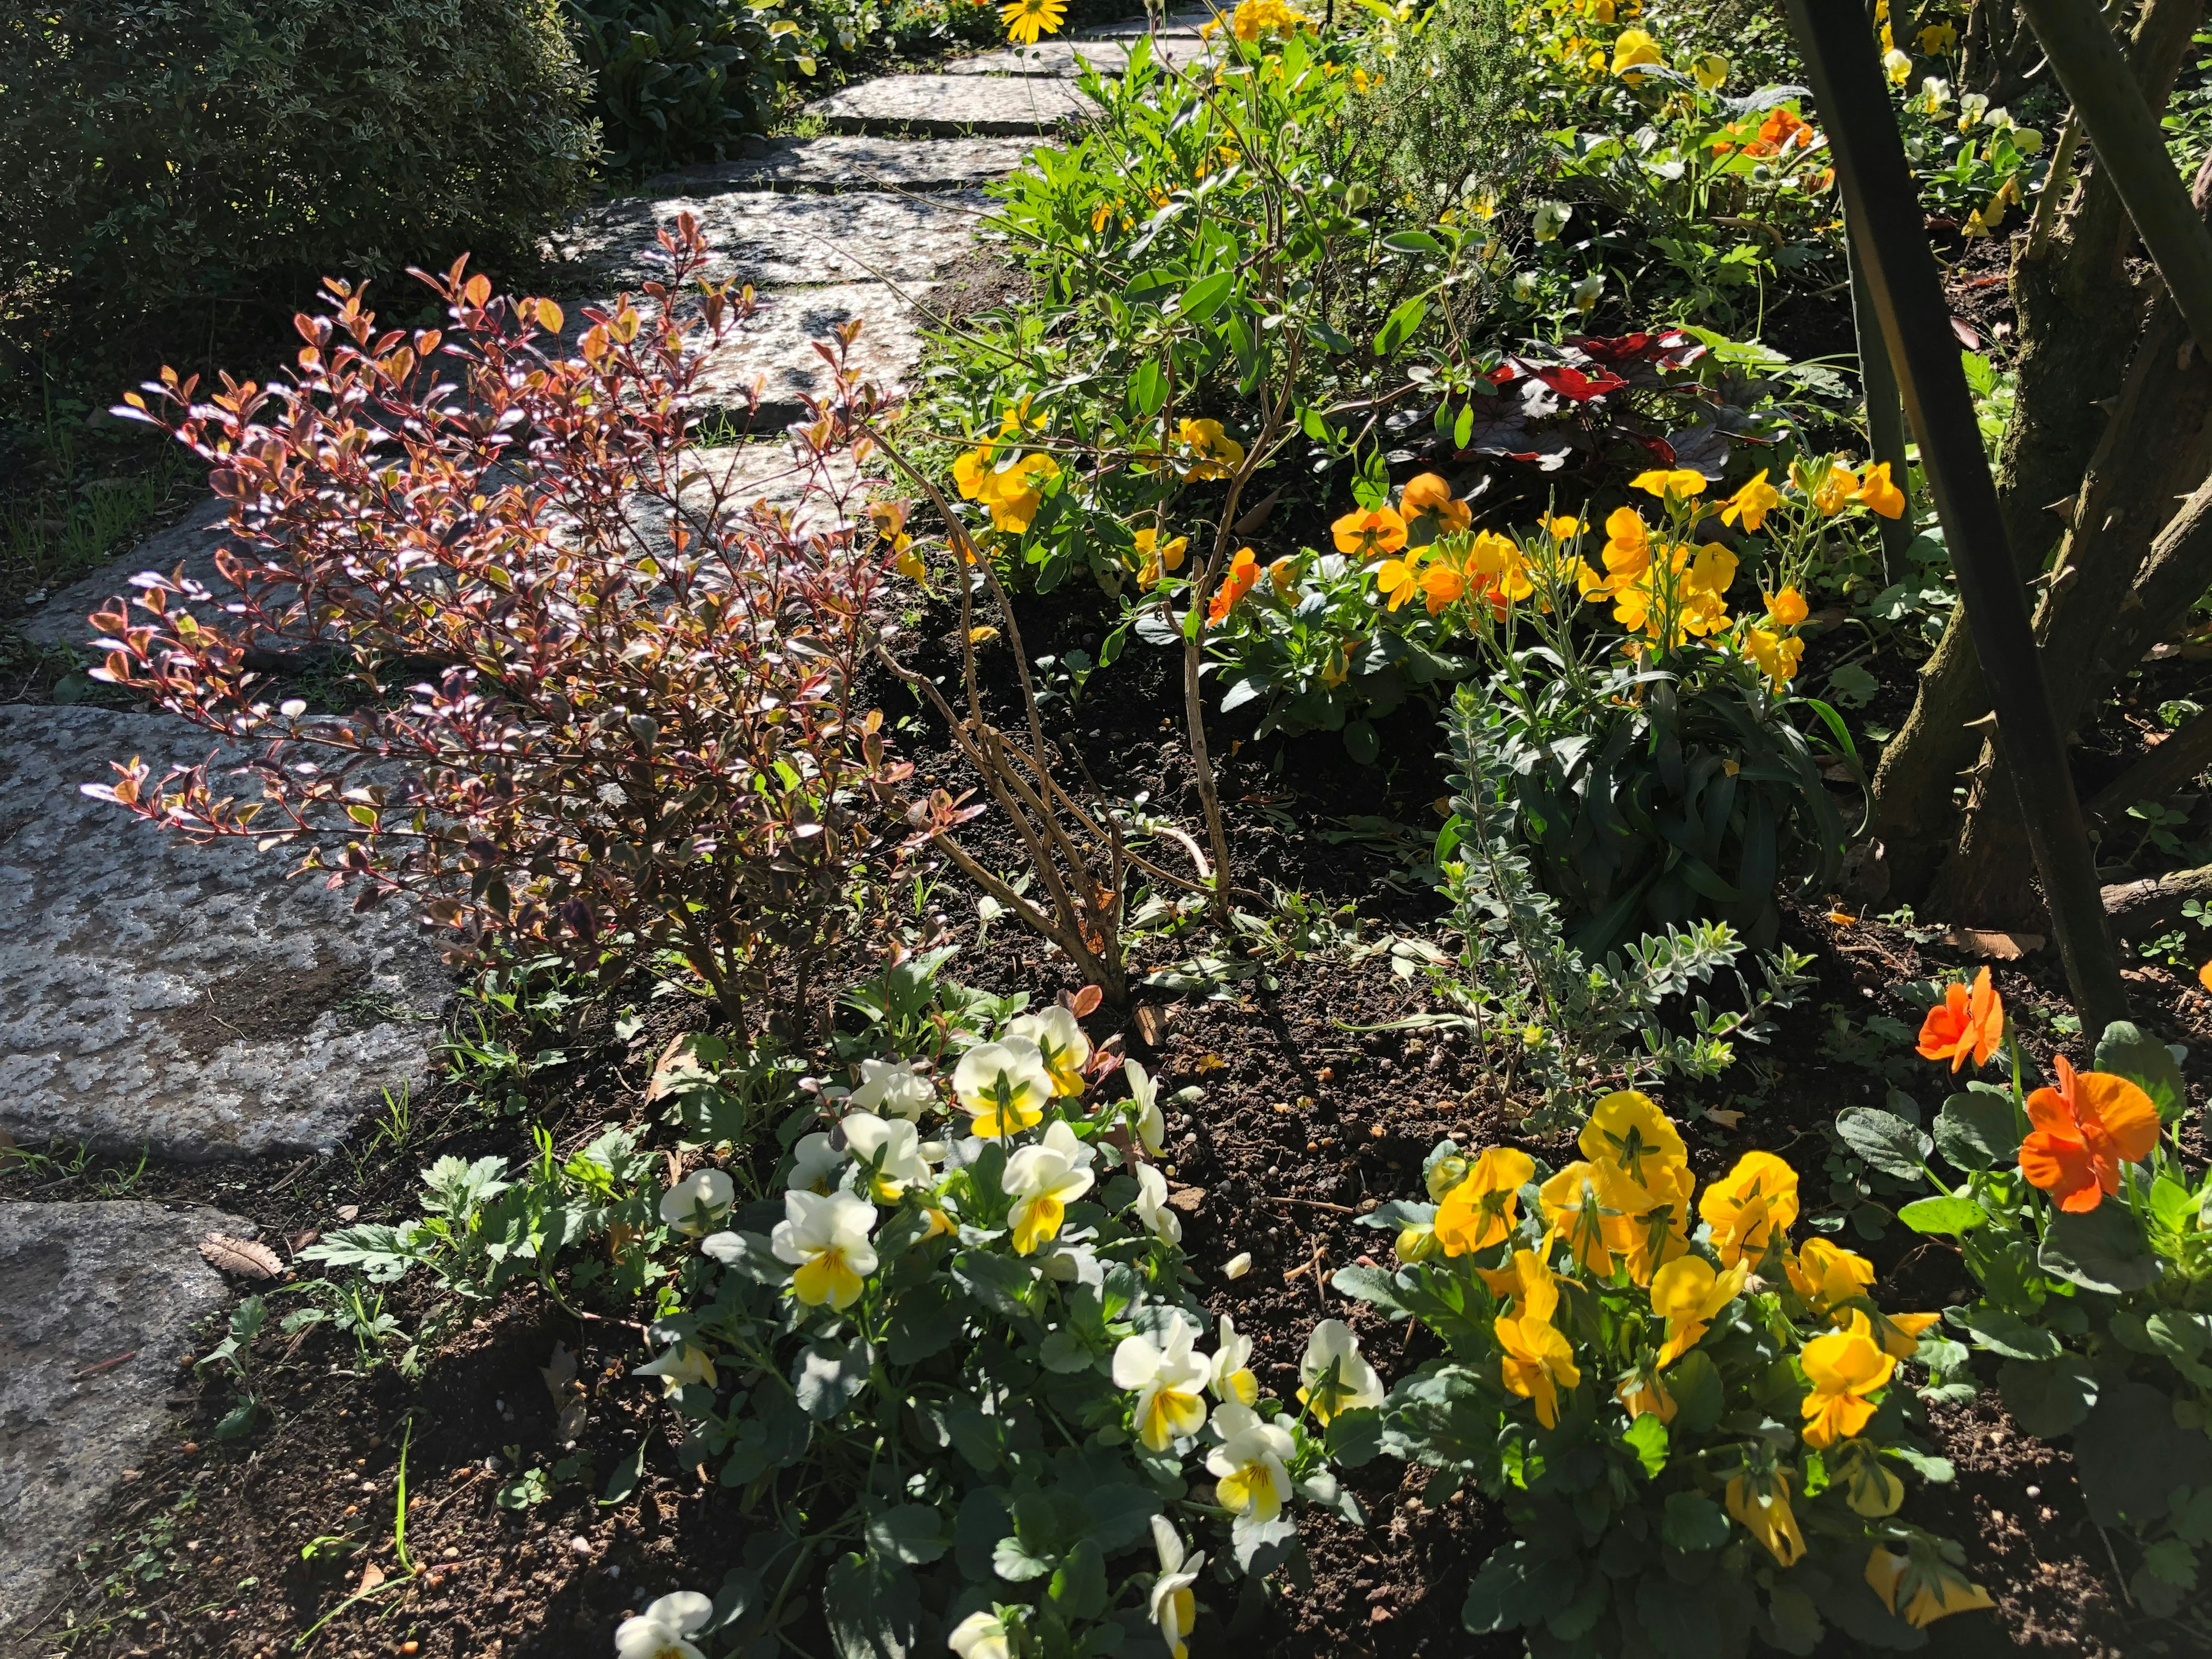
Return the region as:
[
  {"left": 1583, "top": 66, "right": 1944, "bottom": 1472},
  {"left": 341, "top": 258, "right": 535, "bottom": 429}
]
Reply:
[{"left": 1933, "top": 159, "right": 2212, "bottom": 925}]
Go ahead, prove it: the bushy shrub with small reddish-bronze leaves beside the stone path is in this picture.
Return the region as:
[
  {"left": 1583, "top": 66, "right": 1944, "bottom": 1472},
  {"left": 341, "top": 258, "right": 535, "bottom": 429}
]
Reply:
[{"left": 86, "top": 217, "right": 907, "bottom": 1029}]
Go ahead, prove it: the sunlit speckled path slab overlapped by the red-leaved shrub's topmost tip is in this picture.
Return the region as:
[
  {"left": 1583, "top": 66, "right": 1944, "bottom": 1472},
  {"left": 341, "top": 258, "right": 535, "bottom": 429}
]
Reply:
[{"left": 560, "top": 190, "right": 991, "bottom": 287}]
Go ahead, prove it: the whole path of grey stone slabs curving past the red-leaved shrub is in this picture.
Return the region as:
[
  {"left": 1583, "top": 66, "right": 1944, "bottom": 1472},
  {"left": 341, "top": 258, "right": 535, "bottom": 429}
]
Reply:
[{"left": 0, "top": 13, "right": 1208, "bottom": 1650}]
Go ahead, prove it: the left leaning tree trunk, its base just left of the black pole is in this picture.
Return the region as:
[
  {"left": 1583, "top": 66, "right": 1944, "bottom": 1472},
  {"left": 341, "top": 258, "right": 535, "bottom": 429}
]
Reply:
[{"left": 1872, "top": 0, "right": 2203, "bottom": 903}]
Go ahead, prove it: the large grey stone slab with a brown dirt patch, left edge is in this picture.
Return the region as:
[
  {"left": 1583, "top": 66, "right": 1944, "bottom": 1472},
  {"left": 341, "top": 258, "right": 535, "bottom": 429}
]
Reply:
[{"left": 0, "top": 703, "right": 451, "bottom": 1159}]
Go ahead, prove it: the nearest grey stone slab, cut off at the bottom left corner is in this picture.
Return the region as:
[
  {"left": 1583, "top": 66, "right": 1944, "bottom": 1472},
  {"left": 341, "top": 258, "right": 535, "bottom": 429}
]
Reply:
[{"left": 0, "top": 1203, "right": 250, "bottom": 1652}]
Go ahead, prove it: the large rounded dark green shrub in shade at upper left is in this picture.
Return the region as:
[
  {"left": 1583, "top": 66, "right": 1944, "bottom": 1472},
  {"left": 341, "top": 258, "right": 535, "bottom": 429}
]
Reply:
[{"left": 0, "top": 0, "right": 595, "bottom": 345}]
